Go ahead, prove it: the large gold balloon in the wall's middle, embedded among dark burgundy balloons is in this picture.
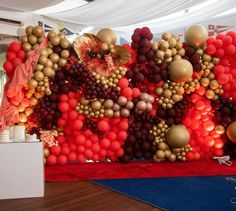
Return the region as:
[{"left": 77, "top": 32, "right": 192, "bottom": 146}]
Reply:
[{"left": 169, "top": 59, "right": 193, "bottom": 83}]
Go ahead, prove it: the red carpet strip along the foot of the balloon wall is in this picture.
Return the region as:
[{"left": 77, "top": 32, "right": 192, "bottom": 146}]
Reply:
[{"left": 45, "top": 160, "right": 236, "bottom": 181}]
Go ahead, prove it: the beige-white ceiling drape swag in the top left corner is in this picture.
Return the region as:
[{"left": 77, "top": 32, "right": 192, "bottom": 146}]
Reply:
[{"left": 0, "top": 0, "right": 63, "bottom": 11}]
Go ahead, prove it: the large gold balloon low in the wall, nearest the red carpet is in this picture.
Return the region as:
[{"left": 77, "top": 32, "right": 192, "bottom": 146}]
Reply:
[{"left": 166, "top": 125, "right": 190, "bottom": 148}]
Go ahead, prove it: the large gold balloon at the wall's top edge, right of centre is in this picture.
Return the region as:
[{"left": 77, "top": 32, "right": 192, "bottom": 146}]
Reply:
[{"left": 185, "top": 24, "right": 208, "bottom": 48}]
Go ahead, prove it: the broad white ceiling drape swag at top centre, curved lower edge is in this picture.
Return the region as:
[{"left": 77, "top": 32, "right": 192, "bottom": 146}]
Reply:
[{"left": 48, "top": 0, "right": 208, "bottom": 27}]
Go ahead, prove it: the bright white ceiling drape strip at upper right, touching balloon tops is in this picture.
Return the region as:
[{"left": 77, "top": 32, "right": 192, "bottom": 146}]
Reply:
[{"left": 113, "top": 0, "right": 236, "bottom": 34}]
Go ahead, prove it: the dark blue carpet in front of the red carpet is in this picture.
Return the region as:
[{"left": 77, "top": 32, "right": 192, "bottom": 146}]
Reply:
[{"left": 91, "top": 176, "right": 236, "bottom": 211}]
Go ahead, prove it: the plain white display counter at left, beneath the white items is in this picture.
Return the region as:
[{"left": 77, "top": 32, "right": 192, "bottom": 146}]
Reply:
[{"left": 0, "top": 142, "right": 44, "bottom": 199}]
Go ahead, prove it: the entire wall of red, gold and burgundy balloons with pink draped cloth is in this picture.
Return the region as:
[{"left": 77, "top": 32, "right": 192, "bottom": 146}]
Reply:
[{"left": 0, "top": 25, "right": 236, "bottom": 165}]
